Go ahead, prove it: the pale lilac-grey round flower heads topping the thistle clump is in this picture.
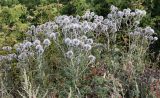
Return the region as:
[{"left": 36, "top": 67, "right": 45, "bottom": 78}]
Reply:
[{"left": 1, "top": 5, "right": 158, "bottom": 62}]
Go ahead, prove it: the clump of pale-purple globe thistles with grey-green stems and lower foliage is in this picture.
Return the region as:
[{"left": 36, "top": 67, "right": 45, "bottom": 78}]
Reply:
[{"left": 0, "top": 5, "right": 158, "bottom": 98}]
